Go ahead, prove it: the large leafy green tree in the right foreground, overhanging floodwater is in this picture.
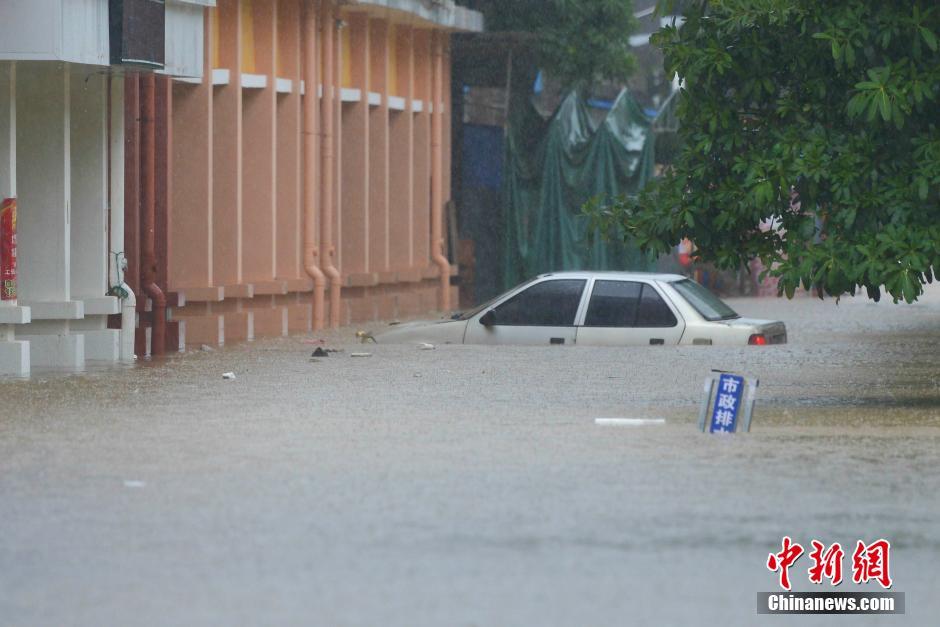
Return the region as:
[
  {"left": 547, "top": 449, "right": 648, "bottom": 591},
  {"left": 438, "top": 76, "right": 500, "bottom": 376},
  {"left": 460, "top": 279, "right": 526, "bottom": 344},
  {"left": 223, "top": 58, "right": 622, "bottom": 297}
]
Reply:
[{"left": 587, "top": 0, "right": 940, "bottom": 302}]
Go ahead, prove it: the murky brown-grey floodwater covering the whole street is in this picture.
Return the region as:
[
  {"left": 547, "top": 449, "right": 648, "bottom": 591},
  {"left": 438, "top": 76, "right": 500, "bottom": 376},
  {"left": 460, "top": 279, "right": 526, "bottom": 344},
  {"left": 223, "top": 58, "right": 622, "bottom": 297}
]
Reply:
[{"left": 0, "top": 290, "right": 940, "bottom": 625}]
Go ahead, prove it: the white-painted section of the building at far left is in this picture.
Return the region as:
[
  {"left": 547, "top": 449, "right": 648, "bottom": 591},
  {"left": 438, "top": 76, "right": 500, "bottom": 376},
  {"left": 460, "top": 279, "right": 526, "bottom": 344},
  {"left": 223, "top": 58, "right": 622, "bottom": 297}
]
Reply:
[{"left": 0, "top": 0, "right": 214, "bottom": 375}]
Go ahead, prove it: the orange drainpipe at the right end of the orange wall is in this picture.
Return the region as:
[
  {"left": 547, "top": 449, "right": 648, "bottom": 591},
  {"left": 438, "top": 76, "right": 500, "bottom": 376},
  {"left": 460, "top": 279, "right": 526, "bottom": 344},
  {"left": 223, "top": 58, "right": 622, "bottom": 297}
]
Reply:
[{"left": 431, "top": 33, "right": 450, "bottom": 312}]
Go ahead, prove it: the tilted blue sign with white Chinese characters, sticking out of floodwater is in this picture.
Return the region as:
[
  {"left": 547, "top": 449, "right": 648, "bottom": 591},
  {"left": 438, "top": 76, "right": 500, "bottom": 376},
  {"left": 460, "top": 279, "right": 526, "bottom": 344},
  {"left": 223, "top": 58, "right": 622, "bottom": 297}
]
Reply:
[{"left": 698, "top": 371, "right": 760, "bottom": 433}]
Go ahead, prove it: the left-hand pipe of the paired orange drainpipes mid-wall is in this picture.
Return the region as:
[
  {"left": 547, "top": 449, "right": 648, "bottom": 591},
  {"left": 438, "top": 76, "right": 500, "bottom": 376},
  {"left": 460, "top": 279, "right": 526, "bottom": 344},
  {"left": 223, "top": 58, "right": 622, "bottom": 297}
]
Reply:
[{"left": 303, "top": 0, "right": 326, "bottom": 331}]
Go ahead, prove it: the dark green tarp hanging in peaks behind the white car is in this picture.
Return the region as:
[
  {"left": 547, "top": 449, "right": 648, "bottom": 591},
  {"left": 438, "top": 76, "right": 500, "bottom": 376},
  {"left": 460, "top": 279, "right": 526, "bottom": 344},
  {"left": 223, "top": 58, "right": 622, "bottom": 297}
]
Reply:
[{"left": 501, "top": 90, "right": 654, "bottom": 289}]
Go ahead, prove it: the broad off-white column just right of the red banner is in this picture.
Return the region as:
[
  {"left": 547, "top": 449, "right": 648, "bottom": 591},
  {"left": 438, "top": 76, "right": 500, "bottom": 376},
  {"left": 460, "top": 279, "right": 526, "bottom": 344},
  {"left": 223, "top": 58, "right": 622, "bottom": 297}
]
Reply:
[{"left": 16, "top": 62, "right": 85, "bottom": 368}]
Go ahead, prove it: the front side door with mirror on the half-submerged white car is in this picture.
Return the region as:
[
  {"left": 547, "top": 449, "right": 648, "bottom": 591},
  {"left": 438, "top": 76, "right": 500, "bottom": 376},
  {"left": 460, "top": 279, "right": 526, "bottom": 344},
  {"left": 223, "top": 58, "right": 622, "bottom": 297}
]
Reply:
[{"left": 464, "top": 278, "right": 587, "bottom": 346}]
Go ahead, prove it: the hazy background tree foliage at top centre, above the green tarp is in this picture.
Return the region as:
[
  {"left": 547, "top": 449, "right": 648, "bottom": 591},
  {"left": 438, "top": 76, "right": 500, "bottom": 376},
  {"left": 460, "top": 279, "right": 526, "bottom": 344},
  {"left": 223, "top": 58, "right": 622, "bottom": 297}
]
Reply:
[{"left": 475, "top": 0, "right": 636, "bottom": 88}]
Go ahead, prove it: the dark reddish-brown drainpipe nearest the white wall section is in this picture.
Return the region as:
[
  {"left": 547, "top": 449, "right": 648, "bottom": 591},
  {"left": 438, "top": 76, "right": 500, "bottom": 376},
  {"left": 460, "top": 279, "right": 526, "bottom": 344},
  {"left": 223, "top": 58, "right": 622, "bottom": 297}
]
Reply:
[{"left": 140, "top": 73, "right": 166, "bottom": 356}]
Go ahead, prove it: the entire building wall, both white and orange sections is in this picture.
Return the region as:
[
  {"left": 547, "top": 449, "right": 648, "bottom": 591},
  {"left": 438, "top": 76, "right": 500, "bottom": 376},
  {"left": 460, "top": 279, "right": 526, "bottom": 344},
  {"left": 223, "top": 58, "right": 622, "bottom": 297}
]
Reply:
[{"left": 0, "top": 0, "right": 466, "bottom": 374}]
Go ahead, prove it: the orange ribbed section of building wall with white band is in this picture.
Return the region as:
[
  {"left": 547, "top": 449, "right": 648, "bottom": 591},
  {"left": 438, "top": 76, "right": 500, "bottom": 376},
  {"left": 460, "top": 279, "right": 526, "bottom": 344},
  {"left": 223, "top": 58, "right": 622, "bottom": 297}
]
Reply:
[{"left": 165, "top": 0, "right": 464, "bottom": 344}]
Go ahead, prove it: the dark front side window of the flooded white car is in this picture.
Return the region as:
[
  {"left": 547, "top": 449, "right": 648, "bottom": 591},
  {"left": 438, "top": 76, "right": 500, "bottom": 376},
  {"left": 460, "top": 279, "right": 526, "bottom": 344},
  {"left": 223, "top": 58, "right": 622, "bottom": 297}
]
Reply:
[{"left": 493, "top": 279, "right": 587, "bottom": 327}]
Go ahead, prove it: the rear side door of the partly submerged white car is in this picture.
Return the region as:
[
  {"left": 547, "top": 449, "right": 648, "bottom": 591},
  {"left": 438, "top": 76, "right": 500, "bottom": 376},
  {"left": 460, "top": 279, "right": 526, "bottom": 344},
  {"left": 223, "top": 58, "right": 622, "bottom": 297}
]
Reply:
[{"left": 577, "top": 279, "right": 685, "bottom": 346}]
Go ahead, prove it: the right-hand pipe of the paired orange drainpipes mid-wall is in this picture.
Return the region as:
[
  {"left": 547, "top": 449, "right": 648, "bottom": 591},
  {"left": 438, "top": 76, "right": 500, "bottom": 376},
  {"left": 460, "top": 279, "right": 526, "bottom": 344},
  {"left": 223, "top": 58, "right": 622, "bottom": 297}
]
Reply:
[{"left": 320, "top": 0, "right": 341, "bottom": 329}]
